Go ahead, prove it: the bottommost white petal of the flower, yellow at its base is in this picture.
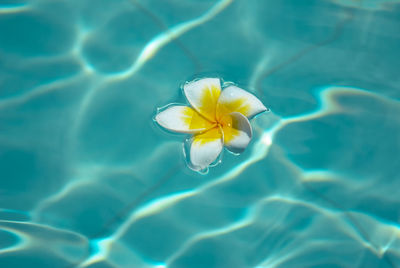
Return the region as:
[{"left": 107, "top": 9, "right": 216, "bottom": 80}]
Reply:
[{"left": 190, "top": 127, "right": 224, "bottom": 170}]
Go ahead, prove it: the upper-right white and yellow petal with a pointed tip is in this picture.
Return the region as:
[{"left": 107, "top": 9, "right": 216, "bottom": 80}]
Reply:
[{"left": 217, "top": 86, "right": 268, "bottom": 118}]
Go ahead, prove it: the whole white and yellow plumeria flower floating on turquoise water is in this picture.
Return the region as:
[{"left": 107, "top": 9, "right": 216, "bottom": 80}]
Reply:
[{"left": 155, "top": 78, "right": 268, "bottom": 171}]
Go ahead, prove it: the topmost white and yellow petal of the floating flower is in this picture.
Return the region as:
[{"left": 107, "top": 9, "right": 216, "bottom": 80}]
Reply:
[{"left": 183, "top": 78, "right": 221, "bottom": 122}]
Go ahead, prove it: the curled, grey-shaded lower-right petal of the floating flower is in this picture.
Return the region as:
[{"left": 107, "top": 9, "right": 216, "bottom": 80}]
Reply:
[{"left": 222, "top": 112, "right": 253, "bottom": 153}]
